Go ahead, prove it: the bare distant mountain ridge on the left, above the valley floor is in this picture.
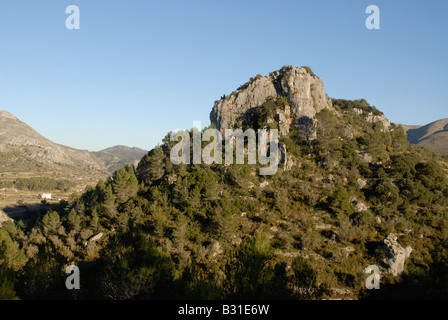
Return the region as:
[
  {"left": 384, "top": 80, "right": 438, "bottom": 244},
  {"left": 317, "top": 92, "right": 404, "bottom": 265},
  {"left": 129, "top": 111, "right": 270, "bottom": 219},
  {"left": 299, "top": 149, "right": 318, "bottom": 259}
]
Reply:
[{"left": 0, "top": 110, "right": 146, "bottom": 176}]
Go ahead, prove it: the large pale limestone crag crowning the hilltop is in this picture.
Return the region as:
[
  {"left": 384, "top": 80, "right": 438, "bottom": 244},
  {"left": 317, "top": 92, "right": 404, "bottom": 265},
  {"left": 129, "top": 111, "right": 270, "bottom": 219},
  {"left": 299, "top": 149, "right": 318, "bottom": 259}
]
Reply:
[{"left": 210, "top": 66, "right": 332, "bottom": 140}]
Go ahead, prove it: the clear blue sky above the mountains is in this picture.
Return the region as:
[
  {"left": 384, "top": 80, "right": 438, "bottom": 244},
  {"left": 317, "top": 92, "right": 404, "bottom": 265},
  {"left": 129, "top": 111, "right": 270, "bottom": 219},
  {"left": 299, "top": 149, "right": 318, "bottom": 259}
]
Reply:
[{"left": 0, "top": 0, "right": 448, "bottom": 150}]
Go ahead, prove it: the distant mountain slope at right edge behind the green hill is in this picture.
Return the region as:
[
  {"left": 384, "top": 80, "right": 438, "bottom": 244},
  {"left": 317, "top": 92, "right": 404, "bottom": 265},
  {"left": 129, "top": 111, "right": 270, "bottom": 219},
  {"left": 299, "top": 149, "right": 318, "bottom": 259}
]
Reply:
[{"left": 403, "top": 118, "right": 448, "bottom": 154}]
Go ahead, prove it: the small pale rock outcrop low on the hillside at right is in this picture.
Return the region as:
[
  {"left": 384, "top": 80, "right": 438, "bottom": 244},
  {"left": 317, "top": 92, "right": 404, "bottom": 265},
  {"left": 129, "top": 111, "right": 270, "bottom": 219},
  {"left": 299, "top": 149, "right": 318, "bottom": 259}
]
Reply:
[{"left": 379, "top": 233, "right": 412, "bottom": 276}]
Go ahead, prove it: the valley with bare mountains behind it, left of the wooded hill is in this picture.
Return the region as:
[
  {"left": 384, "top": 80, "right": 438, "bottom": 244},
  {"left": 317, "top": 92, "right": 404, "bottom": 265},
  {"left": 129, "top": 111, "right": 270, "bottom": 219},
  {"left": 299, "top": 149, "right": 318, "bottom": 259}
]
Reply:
[{"left": 0, "top": 110, "right": 147, "bottom": 221}]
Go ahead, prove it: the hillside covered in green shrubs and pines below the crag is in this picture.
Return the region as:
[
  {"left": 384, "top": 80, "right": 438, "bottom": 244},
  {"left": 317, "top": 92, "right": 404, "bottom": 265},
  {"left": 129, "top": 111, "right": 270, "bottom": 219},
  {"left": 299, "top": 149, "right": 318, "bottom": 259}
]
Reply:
[{"left": 0, "top": 68, "right": 448, "bottom": 299}]
